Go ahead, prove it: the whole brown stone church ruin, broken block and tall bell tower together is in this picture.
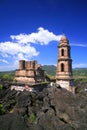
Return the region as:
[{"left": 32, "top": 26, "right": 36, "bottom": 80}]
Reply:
[{"left": 15, "top": 35, "right": 75, "bottom": 93}]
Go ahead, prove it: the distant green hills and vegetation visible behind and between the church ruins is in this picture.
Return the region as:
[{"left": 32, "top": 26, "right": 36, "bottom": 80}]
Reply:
[{"left": 0, "top": 65, "right": 87, "bottom": 83}]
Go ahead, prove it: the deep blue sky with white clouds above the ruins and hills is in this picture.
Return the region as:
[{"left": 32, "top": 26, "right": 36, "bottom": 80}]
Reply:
[{"left": 0, "top": 0, "right": 87, "bottom": 71}]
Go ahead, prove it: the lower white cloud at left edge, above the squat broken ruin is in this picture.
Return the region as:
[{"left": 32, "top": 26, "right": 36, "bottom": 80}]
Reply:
[{"left": 0, "top": 42, "right": 39, "bottom": 60}]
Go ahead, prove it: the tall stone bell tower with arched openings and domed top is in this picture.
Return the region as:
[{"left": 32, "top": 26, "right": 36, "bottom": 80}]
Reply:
[{"left": 56, "top": 35, "right": 73, "bottom": 90}]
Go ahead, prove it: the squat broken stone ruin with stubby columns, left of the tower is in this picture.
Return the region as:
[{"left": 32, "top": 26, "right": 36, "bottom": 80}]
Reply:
[{"left": 15, "top": 60, "right": 45, "bottom": 83}]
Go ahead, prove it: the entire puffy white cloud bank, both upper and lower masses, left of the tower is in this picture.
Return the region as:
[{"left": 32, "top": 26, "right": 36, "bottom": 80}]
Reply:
[{"left": 0, "top": 27, "right": 62, "bottom": 69}]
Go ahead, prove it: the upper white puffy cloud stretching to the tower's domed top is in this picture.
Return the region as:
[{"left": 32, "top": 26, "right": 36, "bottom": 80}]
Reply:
[{"left": 11, "top": 27, "right": 62, "bottom": 45}]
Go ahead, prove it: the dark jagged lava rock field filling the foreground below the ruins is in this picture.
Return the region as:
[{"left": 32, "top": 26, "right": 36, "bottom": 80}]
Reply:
[{"left": 0, "top": 80, "right": 87, "bottom": 130}]
